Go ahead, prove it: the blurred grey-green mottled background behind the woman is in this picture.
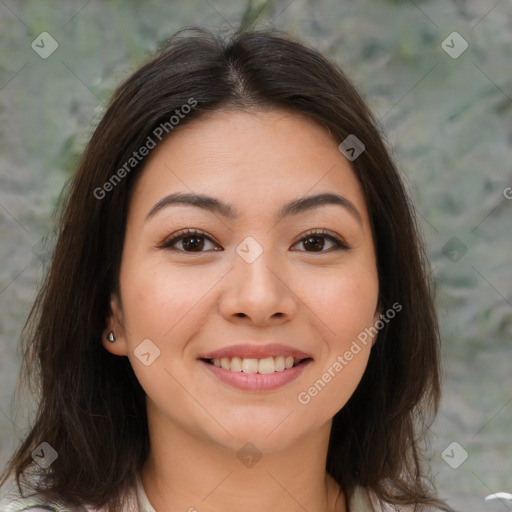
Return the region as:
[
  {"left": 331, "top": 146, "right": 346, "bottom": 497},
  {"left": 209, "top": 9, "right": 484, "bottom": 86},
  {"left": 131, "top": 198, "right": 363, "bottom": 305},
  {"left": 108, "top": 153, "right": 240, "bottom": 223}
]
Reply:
[{"left": 0, "top": 0, "right": 512, "bottom": 511}]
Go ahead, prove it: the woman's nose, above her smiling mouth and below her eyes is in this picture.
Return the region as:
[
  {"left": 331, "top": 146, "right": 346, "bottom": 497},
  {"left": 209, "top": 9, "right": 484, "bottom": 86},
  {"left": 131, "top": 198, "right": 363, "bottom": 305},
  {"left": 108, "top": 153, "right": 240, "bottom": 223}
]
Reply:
[{"left": 219, "top": 245, "right": 298, "bottom": 326}]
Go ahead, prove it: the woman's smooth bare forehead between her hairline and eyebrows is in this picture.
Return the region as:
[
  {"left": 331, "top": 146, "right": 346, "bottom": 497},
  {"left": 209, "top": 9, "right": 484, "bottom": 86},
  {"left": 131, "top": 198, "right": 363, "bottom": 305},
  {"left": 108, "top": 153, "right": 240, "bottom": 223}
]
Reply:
[{"left": 127, "top": 110, "right": 367, "bottom": 225}]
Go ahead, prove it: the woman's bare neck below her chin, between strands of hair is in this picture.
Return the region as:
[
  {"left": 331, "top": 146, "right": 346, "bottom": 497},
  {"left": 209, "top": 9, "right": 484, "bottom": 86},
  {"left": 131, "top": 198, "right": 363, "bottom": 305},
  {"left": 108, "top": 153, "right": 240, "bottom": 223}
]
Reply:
[{"left": 141, "top": 404, "right": 346, "bottom": 512}]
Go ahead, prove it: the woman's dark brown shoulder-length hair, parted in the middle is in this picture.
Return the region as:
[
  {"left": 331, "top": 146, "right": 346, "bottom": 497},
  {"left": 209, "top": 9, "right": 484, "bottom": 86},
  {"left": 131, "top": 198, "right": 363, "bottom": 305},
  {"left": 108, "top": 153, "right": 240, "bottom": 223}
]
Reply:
[{"left": 2, "top": 27, "right": 454, "bottom": 512}]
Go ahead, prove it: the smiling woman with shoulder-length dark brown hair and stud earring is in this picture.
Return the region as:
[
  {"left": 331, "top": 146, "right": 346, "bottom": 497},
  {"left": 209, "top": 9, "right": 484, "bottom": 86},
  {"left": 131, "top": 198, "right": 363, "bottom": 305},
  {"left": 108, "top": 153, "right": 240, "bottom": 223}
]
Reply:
[{"left": 1, "top": 29, "right": 448, "bottom": 512}]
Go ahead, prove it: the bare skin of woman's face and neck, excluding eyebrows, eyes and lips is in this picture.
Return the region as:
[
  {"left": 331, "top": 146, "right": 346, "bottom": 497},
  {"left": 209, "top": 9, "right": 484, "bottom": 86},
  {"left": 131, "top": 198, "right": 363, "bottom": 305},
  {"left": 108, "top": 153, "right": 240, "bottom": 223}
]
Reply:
[{"left": 103, "top": 110, "right": 379, "bottom": 512}]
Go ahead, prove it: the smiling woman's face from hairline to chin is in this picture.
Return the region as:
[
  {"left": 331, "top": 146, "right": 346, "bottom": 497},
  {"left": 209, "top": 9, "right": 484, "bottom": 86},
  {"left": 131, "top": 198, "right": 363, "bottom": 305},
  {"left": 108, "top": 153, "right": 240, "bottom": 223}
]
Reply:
[{"left": 104, "top": 110, "right": 378, "bottom": 451}]
